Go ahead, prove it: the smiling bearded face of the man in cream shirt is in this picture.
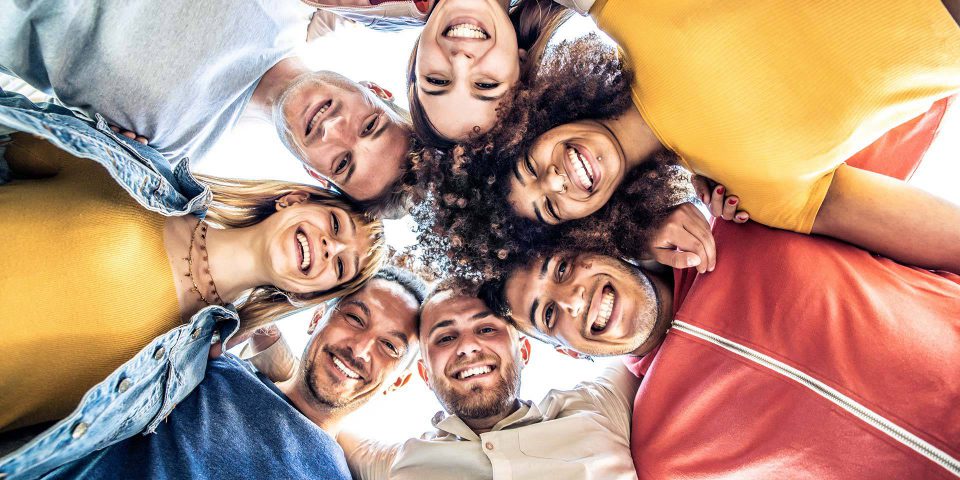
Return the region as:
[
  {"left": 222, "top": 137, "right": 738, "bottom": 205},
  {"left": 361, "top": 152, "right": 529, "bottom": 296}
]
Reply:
[{"left": 420, "top": 292, "right": 529, "bottom": 419}]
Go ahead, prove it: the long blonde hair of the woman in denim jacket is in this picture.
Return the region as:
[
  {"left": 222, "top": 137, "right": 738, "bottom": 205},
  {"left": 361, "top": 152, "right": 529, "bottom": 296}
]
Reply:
[{"left": 196, "top": 175, "right": 387, "bottom": 334}]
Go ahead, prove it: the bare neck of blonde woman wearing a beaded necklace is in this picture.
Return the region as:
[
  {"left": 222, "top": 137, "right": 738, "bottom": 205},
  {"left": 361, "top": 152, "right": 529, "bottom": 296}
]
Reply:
[{"left": 207, "top": 222, "right": 270, "bottom": 303}]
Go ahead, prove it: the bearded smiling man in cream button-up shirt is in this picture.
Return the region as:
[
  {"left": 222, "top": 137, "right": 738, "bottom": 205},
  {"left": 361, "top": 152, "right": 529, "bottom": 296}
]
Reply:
[{"left": 337, "top": 280, "right": 639, "bottom": 480}]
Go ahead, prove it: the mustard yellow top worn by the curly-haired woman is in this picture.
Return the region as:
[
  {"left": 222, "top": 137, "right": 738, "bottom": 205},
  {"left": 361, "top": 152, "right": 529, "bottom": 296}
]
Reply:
[{"left": 590, "top": 0, "right": 960, "bottom": 233}]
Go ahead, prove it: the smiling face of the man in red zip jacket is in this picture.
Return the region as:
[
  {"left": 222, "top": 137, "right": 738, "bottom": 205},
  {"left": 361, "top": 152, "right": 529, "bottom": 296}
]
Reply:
[{"left": 505, "top": 253, "right": 666, "bottom": 355}]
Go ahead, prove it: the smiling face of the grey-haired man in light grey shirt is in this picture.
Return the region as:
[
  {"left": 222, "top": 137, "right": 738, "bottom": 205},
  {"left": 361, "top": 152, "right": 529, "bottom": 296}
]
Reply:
[{"left": 273, "top": 72, "right": 410, "bottom": 200}]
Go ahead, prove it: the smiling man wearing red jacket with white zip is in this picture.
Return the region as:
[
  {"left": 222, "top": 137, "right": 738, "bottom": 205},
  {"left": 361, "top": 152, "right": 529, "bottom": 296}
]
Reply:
[{"left": 483, "top": 222, "right": 960, "bottom": 479}]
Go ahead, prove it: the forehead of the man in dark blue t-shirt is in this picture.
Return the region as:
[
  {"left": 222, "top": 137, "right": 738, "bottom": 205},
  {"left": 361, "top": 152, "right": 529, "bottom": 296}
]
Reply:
[{"left": 343, "top": 278, "right": 418, "bottom": 333}]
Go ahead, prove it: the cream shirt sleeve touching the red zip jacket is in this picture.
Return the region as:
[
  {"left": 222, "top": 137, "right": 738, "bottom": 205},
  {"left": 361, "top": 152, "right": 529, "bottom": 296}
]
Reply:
[{"left": 577, "top": 360, "right": 641, "bottom": 442}]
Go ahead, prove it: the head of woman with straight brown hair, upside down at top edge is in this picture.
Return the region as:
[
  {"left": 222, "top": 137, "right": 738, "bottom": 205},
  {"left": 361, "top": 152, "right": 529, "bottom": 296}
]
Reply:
[{"left": 407, "top": 0, "right": 571, "bottom": 148}]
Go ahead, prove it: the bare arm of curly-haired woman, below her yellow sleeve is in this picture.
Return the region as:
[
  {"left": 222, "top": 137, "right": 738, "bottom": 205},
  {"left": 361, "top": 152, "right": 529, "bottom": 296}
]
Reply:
[{"left": 812, "top": 165, "right": 960, "bottom": 273}]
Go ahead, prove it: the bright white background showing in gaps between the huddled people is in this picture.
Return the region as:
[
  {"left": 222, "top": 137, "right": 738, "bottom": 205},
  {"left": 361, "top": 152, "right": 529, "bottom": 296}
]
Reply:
[{"left": 195, "top": 13, "right": 960, "bottom": 442}]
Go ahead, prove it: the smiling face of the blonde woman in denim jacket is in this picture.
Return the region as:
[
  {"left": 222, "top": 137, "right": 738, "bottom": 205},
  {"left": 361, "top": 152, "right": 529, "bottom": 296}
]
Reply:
[{"left": 258, "top": 196, "right": 373, "bottom": 293}]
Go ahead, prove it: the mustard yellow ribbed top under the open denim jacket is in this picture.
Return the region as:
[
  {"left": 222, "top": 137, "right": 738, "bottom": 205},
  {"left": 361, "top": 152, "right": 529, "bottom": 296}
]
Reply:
[{"left": 0, "top": 134, "right": 180, "bottom": 431}]
